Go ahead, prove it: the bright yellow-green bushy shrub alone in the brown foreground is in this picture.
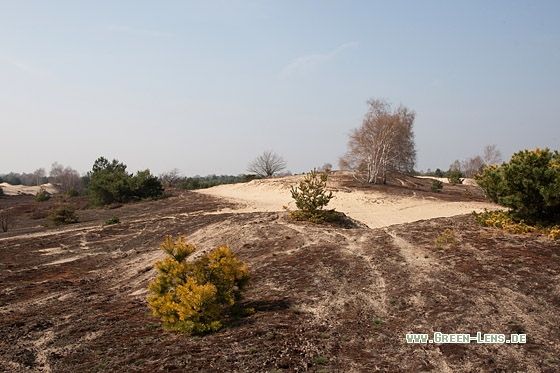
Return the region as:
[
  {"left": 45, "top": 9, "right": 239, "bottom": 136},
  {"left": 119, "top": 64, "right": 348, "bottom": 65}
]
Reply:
[{"left": 148, "top": 236, "right": 251, "bottom": 334}]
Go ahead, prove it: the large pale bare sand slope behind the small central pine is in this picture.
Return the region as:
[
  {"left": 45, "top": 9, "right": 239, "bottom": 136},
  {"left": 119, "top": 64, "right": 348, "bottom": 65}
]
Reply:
[{"left": 198, "top": 176, "right": 496, "bottom": 228}]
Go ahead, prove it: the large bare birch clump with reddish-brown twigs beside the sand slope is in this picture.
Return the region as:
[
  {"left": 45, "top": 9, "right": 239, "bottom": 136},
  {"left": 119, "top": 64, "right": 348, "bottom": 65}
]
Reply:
[{"left": 339, "top": 100, "right": 416, "bottom": 184}]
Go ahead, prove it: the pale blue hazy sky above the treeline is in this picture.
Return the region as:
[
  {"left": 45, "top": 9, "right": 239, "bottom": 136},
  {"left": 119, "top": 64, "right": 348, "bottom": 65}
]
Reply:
[{"left": 0, "top": 0, "right": 560, "bottom": 175}]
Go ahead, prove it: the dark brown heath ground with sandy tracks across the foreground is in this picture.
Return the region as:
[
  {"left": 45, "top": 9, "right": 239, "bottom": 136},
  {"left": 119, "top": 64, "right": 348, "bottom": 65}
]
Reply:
[{"left": 0, "top": 183, "right": 560, "bottom": 372}]
